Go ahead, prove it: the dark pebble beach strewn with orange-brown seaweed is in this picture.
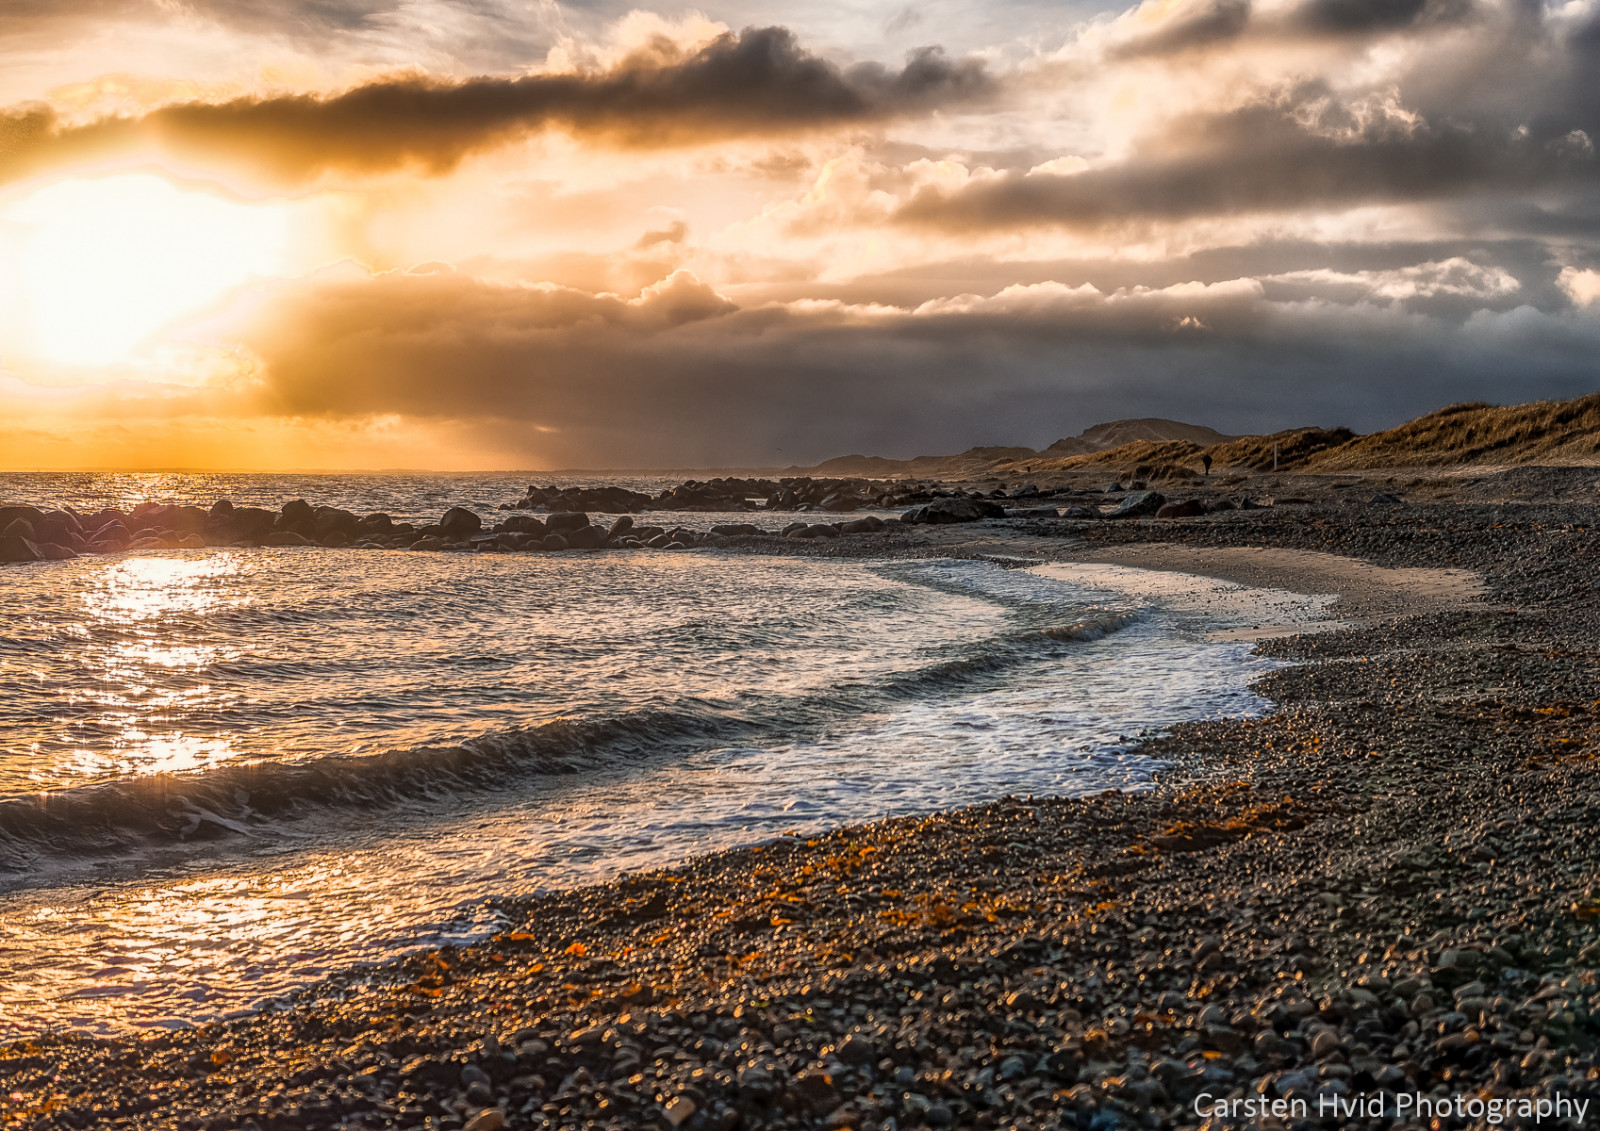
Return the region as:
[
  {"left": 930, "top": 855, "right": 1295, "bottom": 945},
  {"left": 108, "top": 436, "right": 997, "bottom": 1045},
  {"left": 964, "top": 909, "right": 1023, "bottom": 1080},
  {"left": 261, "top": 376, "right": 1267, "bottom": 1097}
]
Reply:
[{"left": 0, "top": 483, "right": 1600, "bottom": 1131}]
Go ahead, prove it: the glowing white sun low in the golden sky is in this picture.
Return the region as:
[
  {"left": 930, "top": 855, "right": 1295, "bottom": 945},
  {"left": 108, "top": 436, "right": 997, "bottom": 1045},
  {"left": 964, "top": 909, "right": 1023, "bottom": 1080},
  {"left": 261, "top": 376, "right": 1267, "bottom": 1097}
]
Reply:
[{"left": 0, "top": 173, "right": 290, "bottom": 366}]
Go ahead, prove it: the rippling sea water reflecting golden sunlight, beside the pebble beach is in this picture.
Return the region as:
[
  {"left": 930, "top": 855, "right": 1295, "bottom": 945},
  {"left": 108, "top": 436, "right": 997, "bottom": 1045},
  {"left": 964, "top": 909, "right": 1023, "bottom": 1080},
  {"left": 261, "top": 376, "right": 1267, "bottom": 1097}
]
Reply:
[{"left": 0, "top": 475, "right": 1328, "bottom": 1038}]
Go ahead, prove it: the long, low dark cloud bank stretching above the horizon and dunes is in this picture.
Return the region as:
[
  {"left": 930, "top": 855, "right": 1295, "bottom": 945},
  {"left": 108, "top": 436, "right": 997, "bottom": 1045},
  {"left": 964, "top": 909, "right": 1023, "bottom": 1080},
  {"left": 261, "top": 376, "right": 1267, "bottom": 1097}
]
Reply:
[{"left": 228, "top": 262, "right": 1600, "bottom": 467}]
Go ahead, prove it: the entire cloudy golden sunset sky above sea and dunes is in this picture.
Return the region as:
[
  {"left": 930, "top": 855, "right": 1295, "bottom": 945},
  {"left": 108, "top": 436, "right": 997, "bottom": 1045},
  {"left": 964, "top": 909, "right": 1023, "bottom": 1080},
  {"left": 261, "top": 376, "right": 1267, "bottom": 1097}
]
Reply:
[{"left": 0, "top": 0, "right": 1600, "bottom": 470}]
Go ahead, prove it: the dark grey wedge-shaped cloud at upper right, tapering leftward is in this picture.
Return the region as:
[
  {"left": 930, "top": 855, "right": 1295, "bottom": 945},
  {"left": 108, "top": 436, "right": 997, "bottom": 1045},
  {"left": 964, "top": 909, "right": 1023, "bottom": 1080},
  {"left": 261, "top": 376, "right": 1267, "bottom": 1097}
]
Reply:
[{"left": 899, "top": 2, "right": 1600, "bottom": 230}]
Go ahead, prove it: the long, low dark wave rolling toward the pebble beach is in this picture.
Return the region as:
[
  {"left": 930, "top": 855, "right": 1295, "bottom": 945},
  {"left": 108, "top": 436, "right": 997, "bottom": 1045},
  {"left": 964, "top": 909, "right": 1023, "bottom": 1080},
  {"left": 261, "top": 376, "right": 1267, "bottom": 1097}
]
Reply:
[{"left": 0, "top": 609, "right": 1138, "bottom": 875}]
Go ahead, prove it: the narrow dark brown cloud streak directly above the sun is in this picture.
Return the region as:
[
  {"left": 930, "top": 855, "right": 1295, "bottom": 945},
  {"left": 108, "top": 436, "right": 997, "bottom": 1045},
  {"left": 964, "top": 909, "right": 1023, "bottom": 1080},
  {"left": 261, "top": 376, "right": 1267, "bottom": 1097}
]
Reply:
[{"left": 0, "top": 27, "right": 994, "bottom": 182}]
